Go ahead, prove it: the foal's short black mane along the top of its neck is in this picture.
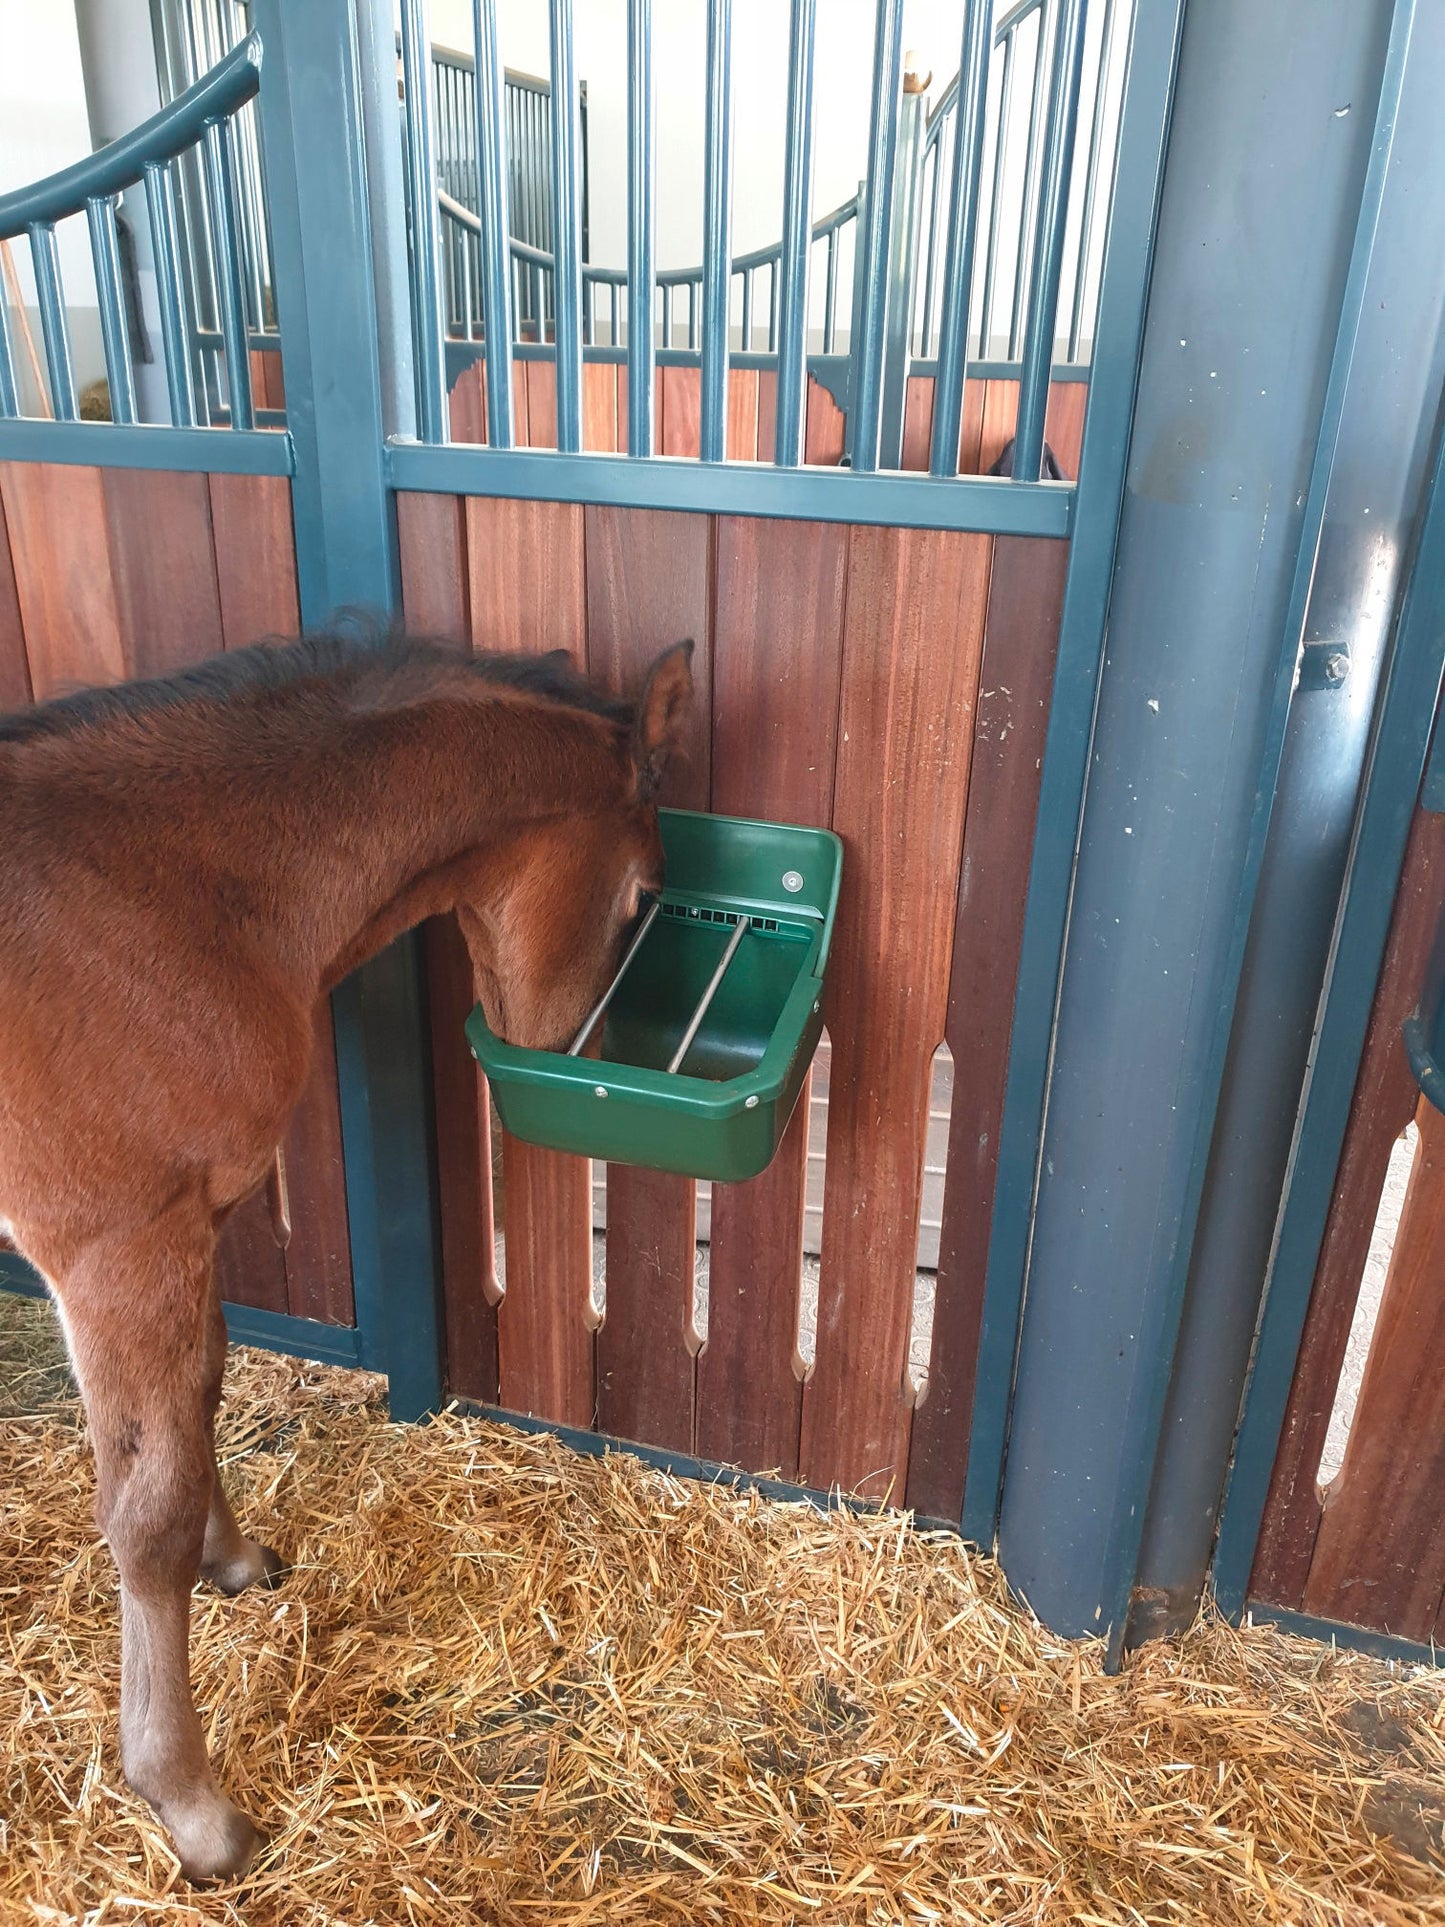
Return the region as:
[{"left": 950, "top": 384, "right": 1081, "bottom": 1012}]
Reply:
[{"left": 0, "top": 630, "right": 634, "bottom": 744}]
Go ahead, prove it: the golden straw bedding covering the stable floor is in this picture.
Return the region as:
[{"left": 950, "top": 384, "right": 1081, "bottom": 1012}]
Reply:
[{"left": 0, "top": 1299, "right": 1445, "bottom": 1927}]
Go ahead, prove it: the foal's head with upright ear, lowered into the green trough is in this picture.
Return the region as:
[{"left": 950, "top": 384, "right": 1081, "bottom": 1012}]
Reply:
[{"left": 457, "top": 642, "right": 692, "bottom": 1050}]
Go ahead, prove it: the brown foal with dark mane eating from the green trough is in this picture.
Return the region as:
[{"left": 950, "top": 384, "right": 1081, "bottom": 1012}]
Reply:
[{"left": 0, "top": 640, "right": 692, "bottom": 1879}]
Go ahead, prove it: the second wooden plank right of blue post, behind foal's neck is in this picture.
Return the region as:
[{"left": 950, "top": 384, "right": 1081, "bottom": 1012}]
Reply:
[{"left": 466, "top": 497, "right": 595, "bottom": 1426}]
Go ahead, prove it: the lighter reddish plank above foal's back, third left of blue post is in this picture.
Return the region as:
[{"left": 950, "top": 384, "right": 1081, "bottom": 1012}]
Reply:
[{"left": 0, "top": 462, "right": 127, "bottom": 701}]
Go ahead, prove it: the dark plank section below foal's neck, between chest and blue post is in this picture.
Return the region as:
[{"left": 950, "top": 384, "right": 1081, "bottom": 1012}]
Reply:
[{"left": 285, "top": 998, "right": 356, "bottom": 1324}]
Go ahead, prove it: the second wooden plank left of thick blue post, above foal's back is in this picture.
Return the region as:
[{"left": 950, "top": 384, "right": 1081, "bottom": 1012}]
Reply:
[{"left": 102, "top": 468, "right": 225, "bottom": 676}]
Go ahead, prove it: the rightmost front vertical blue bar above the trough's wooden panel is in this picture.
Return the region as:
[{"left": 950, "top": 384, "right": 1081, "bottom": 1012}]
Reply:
[{"left": 1013, "top": 0, "right": 1085, "bottom": 482}]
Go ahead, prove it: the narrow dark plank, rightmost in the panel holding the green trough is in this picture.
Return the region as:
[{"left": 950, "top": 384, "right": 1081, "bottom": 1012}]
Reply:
[{"left": 907, "top": 536, "right": 1069, "bottom": 1518}]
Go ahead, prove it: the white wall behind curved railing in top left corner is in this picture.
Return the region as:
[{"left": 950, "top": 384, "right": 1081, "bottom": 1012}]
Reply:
[{"left": 0, "top": 0, "right": 106, "bottom": 410}]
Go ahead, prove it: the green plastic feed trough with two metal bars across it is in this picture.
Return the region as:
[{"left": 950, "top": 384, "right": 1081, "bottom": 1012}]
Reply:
[{"left": 466, "top": 809, "right": 842, "bottom": 1181}]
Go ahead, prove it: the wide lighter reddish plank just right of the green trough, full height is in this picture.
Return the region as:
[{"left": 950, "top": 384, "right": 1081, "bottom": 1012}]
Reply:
[{"left": 800, "top": 528, "right": 990, "bottom": 1497}]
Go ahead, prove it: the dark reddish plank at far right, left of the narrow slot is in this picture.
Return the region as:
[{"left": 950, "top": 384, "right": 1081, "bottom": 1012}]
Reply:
[{"left": 1250, "top": 809, "right": 1445, "bottom": 1609}]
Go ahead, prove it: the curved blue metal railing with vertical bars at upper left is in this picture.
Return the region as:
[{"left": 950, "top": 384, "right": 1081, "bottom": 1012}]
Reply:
[{"left": 0, "top": 35, "right": 262, "bottom": 428}]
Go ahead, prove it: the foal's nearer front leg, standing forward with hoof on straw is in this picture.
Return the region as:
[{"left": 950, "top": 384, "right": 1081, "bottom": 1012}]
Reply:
[{"left": 60, "top": 1199, "right": 256, "bottom": 1879}]
